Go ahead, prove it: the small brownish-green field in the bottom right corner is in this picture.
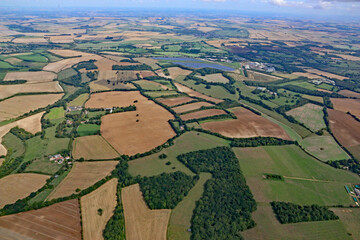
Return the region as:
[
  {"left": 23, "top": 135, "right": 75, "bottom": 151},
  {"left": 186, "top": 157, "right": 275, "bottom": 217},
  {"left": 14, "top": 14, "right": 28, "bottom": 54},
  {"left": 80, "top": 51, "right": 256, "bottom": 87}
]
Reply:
[{"left": 330, "top": 208, "right": 360, "bottom": 239}]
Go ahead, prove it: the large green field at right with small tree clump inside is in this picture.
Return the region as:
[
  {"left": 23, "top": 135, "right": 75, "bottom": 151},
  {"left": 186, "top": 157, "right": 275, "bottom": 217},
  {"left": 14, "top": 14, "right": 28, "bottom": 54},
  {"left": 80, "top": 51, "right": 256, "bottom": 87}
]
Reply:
[{"left": 234, "top": 145, "right": 358, "bottom": 206}]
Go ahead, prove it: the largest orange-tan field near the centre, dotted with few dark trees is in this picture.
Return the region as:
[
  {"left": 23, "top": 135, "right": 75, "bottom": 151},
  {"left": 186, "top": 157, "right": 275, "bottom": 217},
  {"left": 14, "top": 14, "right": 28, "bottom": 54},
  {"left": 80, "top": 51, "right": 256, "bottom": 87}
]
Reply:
[{"left": 86, "top": 91, "right": 175, "bottom": 155}]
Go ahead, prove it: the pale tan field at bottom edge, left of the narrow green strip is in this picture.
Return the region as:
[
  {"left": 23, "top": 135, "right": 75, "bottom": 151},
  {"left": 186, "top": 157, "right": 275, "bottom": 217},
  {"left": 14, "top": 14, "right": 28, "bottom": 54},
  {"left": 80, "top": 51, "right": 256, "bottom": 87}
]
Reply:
[{"left": 121, "top": 184, "right": 171, "bottom": 240}]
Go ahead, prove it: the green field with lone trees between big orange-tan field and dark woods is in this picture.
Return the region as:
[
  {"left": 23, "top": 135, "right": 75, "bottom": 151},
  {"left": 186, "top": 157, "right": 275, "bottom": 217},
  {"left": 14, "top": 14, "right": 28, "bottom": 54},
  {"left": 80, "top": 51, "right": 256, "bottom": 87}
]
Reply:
[{"left": 129, "top": 132, "right": 228, "bottom": 176}]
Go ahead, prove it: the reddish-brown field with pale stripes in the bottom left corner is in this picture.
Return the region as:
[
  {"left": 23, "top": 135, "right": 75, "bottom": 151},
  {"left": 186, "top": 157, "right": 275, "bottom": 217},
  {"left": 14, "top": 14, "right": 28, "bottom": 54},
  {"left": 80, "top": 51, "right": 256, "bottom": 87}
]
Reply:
[{"left": 0, "top": 199, "right": 81, "bottom": 240}]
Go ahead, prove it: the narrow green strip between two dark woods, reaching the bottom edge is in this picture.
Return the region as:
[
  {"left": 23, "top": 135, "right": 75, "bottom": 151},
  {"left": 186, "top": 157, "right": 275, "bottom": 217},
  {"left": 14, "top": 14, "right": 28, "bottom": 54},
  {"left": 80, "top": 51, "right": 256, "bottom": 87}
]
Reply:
[{"left": 167, "top": 173, "right": 211, "bottom": 240}]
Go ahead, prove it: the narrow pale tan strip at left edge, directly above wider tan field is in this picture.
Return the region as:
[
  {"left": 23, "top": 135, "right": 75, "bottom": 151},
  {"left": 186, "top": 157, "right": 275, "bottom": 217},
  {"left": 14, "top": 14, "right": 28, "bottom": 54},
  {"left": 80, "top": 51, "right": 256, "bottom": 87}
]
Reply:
[{"left": 0, "top": 82, "right": 63, "bottom": 99}]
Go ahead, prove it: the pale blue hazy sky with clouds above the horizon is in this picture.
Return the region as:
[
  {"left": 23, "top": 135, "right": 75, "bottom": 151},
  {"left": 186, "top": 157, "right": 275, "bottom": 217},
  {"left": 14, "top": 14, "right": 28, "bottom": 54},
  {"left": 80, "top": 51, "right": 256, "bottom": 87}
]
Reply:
[{"left": 0, "top": 0, "right": 360, "bottom": 20}]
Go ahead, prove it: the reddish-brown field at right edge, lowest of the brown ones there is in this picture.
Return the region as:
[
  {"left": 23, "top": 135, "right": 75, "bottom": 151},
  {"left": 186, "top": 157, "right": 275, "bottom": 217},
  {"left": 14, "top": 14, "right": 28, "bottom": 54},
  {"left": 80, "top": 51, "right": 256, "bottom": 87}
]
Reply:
[{"left": 328, "top": 109, "right": 360, "bottom": 157}]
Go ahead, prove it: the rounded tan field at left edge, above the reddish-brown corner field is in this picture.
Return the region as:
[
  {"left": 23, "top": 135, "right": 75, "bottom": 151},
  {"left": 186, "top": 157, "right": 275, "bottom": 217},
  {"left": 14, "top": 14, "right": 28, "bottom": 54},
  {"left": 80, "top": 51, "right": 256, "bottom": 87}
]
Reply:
[{"left": 0, "top": 173, "right": 49, "bottom": 208}]
